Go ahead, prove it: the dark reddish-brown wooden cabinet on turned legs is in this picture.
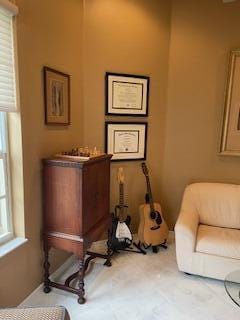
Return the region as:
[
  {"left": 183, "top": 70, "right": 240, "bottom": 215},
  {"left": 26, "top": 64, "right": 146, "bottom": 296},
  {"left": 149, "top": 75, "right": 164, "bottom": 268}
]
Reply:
[{"left": 43, "top": 155, "right": 111, "bottom": 303}]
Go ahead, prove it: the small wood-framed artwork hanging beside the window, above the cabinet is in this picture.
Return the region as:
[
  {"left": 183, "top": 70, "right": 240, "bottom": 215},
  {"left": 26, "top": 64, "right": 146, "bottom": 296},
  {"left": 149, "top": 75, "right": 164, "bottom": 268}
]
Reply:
[{"left": 43, "top": 67, "right": 70, "bottom": 125}]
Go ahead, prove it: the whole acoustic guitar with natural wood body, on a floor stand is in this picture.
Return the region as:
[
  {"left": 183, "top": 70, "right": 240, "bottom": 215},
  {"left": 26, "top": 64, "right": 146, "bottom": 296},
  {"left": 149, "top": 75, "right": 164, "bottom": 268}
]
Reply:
[{"left": 138, "top": 162, "right": 169, "bottom": 247}]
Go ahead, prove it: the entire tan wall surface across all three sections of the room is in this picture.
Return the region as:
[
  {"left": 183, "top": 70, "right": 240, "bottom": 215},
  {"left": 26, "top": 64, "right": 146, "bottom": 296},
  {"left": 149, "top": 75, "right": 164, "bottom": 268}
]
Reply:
[{"left": 0, "top": 0, "right": 240, "bottom": 306}]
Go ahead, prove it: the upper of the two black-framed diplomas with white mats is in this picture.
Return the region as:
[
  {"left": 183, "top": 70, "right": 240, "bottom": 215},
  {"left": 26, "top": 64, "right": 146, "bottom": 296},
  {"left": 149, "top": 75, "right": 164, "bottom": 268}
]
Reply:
[{"left": 106, "top": 72, "right": 149, "bottom": 117}]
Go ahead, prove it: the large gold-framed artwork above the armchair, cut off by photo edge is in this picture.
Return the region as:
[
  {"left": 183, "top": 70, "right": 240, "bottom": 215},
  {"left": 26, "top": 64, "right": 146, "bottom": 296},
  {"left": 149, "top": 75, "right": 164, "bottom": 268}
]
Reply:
[{"left": 220, "top": 51, "right": 240, "bottom": 156}]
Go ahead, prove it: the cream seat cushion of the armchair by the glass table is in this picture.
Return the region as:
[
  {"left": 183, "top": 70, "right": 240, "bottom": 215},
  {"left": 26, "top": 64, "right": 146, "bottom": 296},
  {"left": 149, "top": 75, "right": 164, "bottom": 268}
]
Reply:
[{"left": 196, "top": 224, "right": 240, "bottom": 260}]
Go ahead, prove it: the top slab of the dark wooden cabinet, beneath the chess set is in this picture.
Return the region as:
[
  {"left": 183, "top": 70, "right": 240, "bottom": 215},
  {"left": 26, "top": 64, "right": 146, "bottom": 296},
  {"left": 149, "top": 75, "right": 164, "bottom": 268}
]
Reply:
[{"left": 42, "top": 154, "right": 112, "bottom": 168}]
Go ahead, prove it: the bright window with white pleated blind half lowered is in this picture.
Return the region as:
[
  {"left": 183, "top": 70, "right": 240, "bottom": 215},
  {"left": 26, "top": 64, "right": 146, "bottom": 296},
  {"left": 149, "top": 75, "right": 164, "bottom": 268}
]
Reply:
[{"left": 0, "top": 0, "right": 17, "bottom": 244}]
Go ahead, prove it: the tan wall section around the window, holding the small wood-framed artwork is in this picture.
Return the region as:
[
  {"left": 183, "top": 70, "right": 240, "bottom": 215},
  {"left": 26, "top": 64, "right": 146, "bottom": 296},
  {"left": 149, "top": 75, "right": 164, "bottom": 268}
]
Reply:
[{"left": 0, "top": 0, "right": 83, "bottom": 306}]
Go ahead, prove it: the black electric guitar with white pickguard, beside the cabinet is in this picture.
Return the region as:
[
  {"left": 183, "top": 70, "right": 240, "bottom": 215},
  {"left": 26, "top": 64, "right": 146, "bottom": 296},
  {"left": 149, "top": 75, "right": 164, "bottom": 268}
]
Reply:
[{"left": 110, "top": 168, "right": 132, "bottom": 251}]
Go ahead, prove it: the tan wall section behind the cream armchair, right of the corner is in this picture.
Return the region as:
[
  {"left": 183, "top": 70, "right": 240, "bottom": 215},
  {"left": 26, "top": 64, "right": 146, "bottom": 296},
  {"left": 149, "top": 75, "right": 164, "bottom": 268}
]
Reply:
[{"left": 161, "top": 0, "right": 240, "bottom": 225}]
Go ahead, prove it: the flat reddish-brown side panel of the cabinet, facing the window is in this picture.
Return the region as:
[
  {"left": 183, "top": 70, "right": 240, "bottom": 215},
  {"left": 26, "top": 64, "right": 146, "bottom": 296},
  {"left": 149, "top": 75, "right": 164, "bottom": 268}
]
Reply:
[{"left": 44, "top": 166, "right": 82, "bottom": 235}]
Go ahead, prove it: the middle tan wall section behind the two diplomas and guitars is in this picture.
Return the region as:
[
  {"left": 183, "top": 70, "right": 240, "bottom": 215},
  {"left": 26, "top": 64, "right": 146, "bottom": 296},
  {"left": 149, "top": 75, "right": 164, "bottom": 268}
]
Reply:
[{"left": 83, "top": 0, "right": 170, "bottom": 230}]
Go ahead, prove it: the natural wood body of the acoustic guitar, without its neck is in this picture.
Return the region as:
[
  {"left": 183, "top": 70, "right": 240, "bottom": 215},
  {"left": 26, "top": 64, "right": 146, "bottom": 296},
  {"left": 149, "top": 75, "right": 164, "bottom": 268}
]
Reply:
[{"left": 138, "top": 203, "right": 169, "bottom": 246}]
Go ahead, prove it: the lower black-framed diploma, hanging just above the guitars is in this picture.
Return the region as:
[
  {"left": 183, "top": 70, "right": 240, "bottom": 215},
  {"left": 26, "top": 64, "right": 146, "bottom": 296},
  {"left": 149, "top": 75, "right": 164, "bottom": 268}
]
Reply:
[{"left": 105, "top": 122, "right": 147, "bottom": 161}]
